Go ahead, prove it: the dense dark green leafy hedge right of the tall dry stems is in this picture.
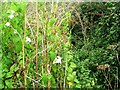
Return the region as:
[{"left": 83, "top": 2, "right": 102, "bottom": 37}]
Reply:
[{"left": 71, "top": 2, "right": 120, "bottom": 89}]
